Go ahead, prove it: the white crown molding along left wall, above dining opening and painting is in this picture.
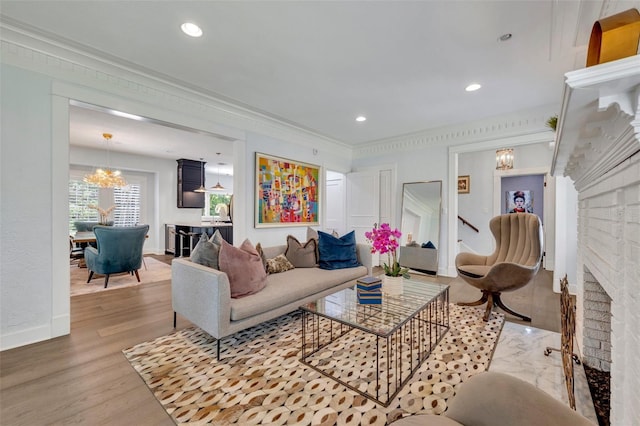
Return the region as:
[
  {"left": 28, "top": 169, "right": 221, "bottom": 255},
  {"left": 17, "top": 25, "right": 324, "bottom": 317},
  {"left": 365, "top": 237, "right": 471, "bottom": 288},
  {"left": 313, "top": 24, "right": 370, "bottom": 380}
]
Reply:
[{"left": 0, "top": 22, "right": 352, "bottom": 156}]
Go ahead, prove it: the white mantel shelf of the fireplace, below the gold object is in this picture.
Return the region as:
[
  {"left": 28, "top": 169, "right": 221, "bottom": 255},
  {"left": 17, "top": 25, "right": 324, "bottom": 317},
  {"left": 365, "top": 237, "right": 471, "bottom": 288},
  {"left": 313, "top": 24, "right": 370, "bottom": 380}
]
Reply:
[{"left": 551, "top": 55, "right": 640, "bottom": 191}]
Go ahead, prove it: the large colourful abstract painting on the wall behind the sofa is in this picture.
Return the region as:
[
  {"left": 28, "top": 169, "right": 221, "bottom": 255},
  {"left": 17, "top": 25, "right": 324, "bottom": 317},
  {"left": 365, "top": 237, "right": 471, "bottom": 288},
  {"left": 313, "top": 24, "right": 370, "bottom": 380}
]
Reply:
[{"left": 255, "top": 152, "right": 320, "bottom": 228}]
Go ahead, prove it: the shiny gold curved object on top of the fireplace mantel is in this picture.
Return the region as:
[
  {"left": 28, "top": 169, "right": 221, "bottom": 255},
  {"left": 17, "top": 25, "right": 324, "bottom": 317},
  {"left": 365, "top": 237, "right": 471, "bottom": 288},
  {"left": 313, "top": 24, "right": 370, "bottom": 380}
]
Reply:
[{"left": 587, "top": 9, "right": 640, "bottom": 67}]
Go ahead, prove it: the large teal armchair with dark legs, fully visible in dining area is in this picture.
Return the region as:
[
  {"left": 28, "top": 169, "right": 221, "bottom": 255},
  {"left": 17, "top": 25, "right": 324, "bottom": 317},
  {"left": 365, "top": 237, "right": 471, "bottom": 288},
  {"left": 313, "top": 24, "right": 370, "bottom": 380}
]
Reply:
[{"left": 84, "top": 225, "right": 149, "bottom": 288}]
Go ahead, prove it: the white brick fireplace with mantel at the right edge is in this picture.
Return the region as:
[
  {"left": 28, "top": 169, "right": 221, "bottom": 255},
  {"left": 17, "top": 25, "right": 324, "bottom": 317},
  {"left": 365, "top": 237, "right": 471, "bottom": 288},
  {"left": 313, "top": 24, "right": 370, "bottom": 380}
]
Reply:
[{"left": 552, "top": 55, "right": 640, "bottom": 426}]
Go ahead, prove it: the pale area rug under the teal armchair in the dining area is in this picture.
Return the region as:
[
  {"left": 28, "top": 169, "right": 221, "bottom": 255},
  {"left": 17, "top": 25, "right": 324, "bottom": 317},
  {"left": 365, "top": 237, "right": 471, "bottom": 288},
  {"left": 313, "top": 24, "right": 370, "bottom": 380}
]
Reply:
[{"left": 70, "top": 256, "right": 171, "bottom": 296}]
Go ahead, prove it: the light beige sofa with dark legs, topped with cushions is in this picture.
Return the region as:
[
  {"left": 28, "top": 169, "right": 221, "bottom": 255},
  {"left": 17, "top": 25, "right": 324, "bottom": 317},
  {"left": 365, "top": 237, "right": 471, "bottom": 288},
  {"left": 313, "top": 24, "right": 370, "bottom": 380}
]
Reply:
[{"left": 171, "top": 244, "right": 371, "bottom": 356}]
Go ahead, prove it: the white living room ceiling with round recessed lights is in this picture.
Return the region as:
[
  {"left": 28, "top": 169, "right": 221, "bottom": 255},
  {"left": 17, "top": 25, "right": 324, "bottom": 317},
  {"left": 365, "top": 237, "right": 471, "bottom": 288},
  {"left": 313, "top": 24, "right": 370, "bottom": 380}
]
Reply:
[{"left": 1, "top": 0, "right": 640, "bottom": 162}]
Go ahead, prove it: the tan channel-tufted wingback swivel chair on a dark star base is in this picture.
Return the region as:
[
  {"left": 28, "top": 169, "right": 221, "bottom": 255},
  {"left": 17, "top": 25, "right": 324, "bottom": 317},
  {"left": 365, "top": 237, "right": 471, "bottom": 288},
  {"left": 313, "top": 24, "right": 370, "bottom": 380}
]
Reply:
[{"left": 456, "top": 213, "right": 543, "bottom": 321}]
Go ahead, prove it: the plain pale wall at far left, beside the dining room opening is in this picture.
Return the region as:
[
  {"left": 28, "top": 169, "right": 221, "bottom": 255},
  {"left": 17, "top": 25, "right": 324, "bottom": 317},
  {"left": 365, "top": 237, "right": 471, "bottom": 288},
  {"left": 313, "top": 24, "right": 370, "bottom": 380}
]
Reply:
[{"left": 0, "top": 67, "right": 57, "bottom": 347}]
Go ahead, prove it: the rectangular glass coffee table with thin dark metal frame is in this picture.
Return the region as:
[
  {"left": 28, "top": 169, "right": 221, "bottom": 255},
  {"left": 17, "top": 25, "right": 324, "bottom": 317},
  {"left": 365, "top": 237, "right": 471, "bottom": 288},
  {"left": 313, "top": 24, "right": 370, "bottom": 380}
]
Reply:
[{"left": 300, "top": 279, "right": 449, "bottom": 407}]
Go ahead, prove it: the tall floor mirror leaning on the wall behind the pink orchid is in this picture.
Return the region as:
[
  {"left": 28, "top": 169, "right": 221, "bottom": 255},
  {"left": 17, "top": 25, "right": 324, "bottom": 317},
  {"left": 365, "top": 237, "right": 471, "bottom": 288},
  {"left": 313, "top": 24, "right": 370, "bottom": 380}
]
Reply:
[{"left": 399, "top": 180, "right": 442, "bottom": 275}]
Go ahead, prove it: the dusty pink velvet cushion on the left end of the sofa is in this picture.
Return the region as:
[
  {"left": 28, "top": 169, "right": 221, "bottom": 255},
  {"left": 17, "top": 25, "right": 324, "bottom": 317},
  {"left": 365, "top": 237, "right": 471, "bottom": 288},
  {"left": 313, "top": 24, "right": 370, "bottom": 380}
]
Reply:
[{"left": 218, "top": 239, "right": 267, "bottom": 298}]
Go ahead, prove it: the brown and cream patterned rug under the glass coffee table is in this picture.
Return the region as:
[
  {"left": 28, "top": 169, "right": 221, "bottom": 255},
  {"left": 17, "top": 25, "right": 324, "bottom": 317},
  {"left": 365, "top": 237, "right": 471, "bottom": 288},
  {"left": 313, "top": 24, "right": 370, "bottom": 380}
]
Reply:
[{"left": 123, "top": 304, "right": 504, "bottom": 425}]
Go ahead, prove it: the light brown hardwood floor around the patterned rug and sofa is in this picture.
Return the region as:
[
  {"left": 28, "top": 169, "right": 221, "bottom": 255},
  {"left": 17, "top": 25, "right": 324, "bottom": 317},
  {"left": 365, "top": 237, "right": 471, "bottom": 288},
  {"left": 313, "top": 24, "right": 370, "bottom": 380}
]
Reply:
[{"left": 0, "top": 264, "right": 560, "bottom": 426}]
